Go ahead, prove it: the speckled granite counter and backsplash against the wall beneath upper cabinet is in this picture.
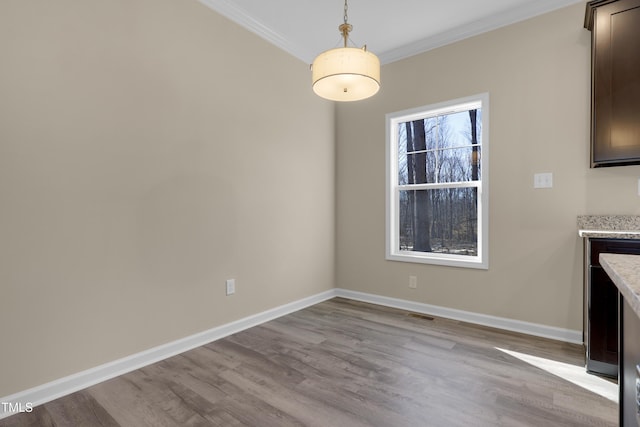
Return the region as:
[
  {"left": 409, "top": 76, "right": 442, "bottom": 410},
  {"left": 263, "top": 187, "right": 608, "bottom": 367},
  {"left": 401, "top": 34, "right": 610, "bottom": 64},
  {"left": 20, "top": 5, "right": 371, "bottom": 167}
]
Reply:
[{"left": 578, "top": 215, "right": 640, "bottom": 239}]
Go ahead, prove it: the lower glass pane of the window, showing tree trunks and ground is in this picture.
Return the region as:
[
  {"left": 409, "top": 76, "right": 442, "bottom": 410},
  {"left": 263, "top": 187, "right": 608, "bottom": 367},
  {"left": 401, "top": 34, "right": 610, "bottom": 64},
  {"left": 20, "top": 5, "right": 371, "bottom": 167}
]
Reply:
[{"left": 398, "top": 187, "right": 478, "bottom": 256}]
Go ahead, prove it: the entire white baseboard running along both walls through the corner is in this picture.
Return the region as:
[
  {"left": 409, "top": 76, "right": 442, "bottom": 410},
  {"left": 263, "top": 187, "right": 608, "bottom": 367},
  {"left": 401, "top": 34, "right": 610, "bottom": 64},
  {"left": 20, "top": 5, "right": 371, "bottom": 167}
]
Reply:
[{"left": 0, "top": 289, "right": 582, "bottom": 419}]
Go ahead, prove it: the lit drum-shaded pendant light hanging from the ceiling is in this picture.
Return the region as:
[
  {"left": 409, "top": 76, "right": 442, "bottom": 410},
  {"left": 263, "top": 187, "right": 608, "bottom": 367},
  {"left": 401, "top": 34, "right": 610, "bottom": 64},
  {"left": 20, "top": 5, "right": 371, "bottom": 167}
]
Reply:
[{"left": 311, "top": 0, "right": 380, "bottom": 101}]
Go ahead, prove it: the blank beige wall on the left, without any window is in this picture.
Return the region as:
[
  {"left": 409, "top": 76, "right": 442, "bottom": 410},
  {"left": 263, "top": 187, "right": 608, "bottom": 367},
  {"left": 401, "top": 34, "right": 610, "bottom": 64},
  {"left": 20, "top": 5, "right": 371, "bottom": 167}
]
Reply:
[{"left": 0, "top": 0, "right": 335, "bottom": 396}]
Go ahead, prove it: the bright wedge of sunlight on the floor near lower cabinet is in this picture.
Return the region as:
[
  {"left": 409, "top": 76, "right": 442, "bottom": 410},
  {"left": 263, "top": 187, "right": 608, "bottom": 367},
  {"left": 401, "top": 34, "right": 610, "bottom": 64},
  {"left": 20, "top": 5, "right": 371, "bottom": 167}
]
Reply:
[{"left": 496, "top": 347, "right": 618, "bottom": 403}]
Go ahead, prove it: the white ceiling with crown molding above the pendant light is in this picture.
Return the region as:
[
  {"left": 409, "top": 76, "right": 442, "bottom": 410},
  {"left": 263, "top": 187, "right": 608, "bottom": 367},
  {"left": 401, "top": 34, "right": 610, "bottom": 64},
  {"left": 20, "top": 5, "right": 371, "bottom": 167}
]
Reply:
[{"left": 200, "top": 0, "right": 584, "bottom": 64}]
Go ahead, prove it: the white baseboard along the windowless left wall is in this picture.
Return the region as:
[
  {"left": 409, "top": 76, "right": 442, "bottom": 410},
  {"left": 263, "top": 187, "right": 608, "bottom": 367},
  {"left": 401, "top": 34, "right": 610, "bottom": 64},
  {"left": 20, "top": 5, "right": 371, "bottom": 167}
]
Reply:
[{"left": 0, "top": 289, "right": 335, "bottom": 419}]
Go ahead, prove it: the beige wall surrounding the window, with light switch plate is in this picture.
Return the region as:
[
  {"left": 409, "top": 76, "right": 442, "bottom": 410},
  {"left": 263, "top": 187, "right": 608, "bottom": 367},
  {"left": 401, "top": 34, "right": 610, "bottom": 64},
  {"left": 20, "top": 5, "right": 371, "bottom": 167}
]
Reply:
[{"left": 336, "top": 4, "right": 640, "bottom": 330}]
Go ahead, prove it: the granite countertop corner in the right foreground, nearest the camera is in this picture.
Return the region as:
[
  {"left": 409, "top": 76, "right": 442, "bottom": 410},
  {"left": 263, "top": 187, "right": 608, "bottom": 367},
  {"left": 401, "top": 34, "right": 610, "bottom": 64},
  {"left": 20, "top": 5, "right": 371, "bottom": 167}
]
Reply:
[{"left": 600, "top": 254, "right": 640, "bottom": 317}]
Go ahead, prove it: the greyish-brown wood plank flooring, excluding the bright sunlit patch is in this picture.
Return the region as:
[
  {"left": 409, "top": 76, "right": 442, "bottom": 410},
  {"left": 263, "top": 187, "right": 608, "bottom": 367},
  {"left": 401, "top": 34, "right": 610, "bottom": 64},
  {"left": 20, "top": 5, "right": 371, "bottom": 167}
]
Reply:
[{"left": 0, "top": 298, "right": 618, "bottom": 427}]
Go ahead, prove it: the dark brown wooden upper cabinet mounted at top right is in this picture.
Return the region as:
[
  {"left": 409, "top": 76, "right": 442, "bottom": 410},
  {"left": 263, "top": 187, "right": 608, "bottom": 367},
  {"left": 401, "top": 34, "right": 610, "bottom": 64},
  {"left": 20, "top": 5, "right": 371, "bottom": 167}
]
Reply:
[{"left": 584, "top": 0, "right": 640, "bottom": 167}]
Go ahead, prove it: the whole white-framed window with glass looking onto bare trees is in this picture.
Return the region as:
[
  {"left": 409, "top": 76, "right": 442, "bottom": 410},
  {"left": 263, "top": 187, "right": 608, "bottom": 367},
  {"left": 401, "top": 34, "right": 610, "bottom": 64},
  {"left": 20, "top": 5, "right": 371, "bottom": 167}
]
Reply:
[{"left": 386, "top": 93, "right": 489, "bottom": 269}]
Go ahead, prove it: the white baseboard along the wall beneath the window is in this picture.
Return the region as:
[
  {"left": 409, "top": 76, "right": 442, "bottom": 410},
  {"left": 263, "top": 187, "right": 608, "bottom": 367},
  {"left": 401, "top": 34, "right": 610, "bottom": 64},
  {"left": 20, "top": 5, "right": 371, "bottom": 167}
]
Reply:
[{"left": 336, "top": 289, "right": 582, "bottom": 344}]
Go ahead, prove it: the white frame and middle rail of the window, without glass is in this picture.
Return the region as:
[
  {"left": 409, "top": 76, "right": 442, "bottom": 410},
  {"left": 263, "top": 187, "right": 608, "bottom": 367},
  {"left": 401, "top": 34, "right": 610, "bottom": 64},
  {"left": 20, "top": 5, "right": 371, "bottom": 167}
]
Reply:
[{"left": 385, "top": 93, "right": 489, "bottom": 270}]
